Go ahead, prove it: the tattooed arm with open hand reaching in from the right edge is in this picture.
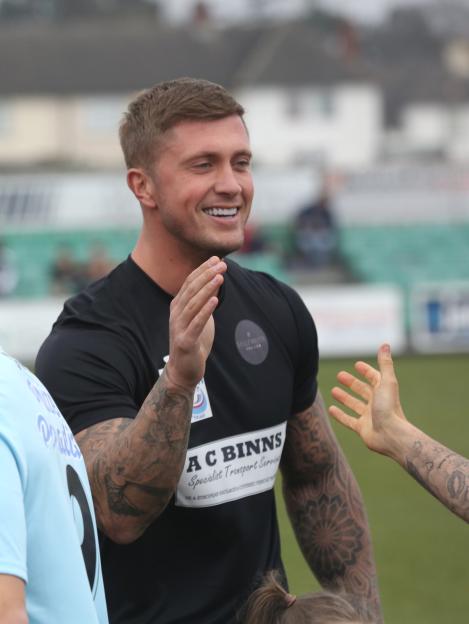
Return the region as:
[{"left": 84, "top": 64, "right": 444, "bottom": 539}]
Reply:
[{"left": 329, "top": 345, "right": 469, "bottom": 522}]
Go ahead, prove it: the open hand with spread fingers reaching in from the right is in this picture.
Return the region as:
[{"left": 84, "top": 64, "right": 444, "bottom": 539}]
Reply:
[{"left": 329, "top": 344, "right": 406, "bottom": 455}]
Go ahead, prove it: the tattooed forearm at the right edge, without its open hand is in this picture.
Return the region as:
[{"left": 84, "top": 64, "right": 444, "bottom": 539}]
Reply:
[{"left": 404, "top": 436, "right": 469, "bottom": 522}]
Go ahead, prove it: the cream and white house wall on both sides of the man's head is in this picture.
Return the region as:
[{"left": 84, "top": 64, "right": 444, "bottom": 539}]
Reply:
[{"left": 0, "top": 85, "right": 382, "bottom": 169}]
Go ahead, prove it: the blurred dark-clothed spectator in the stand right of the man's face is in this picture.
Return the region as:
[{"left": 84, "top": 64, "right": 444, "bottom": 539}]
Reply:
[{"left": 293, "top": 180, "right": 338, "bottom": 269}]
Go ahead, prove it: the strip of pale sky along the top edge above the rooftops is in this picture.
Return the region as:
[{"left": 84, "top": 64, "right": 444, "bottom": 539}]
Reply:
[{"left": 156, "top": 0, "right": 438, "bottom": 23}]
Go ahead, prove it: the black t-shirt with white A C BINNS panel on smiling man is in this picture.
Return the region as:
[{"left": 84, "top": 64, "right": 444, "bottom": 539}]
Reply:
[{"left": 36, "top": 258, "right": 318, "bottom": 624}]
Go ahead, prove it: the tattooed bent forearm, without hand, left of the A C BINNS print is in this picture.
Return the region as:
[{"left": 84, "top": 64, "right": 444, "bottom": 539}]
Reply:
[{"left": 76, "top": 371, "right": 193, "bottom": 542}]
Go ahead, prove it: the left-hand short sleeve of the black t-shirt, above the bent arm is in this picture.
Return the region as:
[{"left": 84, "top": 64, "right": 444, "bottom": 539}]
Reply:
[{"left": 35, "top": 328, "right": 139, "bottom": 434}]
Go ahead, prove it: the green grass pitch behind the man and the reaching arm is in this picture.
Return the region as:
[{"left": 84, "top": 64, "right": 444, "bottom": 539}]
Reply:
[{"left": 277, "top": 354, "right": 469, "bottom": 624}]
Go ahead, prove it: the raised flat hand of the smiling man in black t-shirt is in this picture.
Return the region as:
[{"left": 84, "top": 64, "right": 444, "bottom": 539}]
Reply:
[{"left": 166, "top": 256, "right": 227, "bottom": 390}]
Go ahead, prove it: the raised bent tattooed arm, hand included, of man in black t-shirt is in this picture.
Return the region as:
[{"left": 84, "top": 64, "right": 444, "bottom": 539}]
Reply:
[{"left": 76, "top": 257, "right": 226, "bottom": 543}]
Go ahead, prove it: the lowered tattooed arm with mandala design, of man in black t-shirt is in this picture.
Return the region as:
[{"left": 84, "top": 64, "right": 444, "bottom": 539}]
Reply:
[{"left": 282, "top": 395, "right": 382, "bottom": 622}]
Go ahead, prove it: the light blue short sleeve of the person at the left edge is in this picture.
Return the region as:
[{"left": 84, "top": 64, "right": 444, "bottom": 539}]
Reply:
[{"left": 0, "top": 433, "right": 28, "bottom": 582}]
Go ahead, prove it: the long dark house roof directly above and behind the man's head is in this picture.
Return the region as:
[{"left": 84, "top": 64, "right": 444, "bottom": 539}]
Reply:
[{"left": 0, "top": 19, "right": 362, "bottom": 95}]
